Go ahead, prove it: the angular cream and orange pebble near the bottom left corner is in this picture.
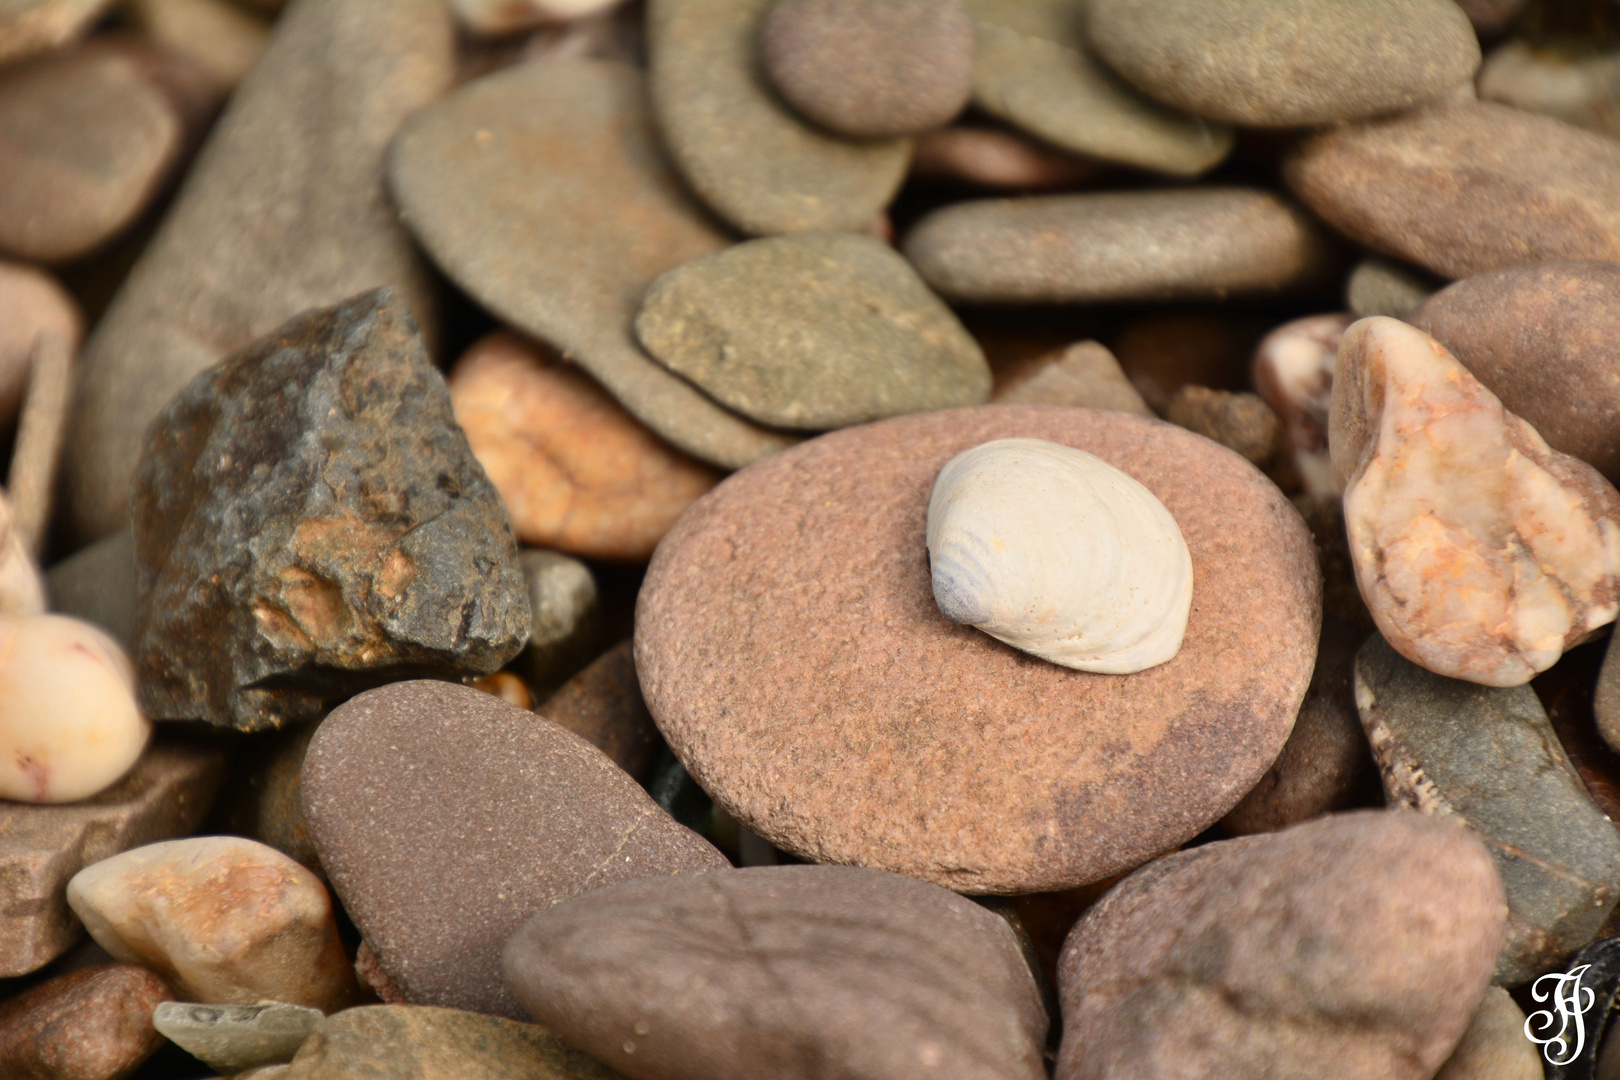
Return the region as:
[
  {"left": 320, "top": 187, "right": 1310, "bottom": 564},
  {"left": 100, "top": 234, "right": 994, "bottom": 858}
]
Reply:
[{"left": 68, "top": 836, "right": 358, "bottom": 1012}]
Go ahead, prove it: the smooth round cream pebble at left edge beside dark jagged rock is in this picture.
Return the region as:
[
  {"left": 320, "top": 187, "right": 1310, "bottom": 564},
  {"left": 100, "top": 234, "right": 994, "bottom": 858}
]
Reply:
[{"left": 0, "top": 615, "right": 152, "bottom": 803}]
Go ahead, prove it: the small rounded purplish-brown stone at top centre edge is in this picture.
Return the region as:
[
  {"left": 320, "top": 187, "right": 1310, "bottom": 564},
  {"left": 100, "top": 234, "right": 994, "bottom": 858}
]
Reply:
[{"left": 760, "top": 0, "right": 974, "bottom": 139}]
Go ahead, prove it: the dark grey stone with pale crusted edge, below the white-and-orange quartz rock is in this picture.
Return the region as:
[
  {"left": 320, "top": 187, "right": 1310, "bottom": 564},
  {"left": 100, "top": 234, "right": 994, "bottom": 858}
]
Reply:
[{"left": 1356, "top": 636, "right": 1620, "bottom": 986}]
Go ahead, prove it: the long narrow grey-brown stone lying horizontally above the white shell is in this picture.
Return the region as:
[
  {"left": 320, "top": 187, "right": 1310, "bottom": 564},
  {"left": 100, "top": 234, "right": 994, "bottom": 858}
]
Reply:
[{"left": 902, "top": 188, "right": 1333, "bottom": 303}]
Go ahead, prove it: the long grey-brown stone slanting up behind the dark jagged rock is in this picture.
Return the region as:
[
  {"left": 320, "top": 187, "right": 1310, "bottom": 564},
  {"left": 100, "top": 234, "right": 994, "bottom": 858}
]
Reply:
[{"left": 63, "top": 0, "right": 452, "bottom": 544}]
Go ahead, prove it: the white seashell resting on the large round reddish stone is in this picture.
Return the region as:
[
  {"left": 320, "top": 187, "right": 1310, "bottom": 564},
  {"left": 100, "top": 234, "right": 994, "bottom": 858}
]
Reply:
[{"left": 928, "top": 439, "right": 1192, "bottom": 675}]
